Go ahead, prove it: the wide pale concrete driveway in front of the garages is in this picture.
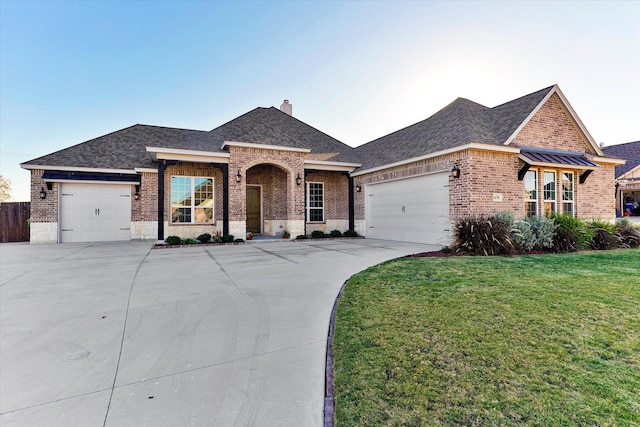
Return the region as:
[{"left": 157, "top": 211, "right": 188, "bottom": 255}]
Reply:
[{"left": 0, "top": 239, "right": 437, "bottom": 427}]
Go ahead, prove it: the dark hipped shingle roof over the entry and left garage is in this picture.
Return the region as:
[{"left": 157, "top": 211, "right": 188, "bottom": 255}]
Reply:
[{"left": 23, "top": 107, "right": 355, "bottom": 169}]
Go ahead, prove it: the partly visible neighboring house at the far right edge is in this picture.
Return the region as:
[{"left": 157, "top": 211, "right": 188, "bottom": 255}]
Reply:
[{"left": 603, "top": 141, "right": 640, "bottom": 216}]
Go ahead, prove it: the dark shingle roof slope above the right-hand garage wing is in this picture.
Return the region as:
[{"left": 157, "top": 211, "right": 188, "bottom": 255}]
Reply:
[{"left": 356, "top": 86, "right": 555, "bottom": 169}]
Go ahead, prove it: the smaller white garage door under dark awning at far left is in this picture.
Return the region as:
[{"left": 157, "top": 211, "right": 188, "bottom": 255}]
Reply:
[{"left": 60, "top": 183, "right": 131, "bottom": 242}]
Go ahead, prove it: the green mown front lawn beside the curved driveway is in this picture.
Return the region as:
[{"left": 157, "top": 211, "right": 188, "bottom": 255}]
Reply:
[{"left": 333, "top": 250, "right": 640, "bottom": 426}]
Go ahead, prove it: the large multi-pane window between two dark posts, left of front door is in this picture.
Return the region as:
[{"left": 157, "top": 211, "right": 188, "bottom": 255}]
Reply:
[{"left": 171, "top": 176, "right": 213, "bottom": 224}]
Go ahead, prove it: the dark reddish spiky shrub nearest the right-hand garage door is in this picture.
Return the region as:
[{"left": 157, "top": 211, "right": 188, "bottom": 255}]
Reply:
[{"left": 453, "top": 215, "right": 515, "bottom": 256}]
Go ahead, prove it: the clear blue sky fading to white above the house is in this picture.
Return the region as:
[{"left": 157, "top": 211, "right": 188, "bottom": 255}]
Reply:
[{"left": 0, "top": 0, "right": 640, "bottom": 201}]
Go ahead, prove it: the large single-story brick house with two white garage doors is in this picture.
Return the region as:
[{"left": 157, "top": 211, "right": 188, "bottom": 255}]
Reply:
[{"left": 21, "top": 86, "right": 623, "bottom": 244}]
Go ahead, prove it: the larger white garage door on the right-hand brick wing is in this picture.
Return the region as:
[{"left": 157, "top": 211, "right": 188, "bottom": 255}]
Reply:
[{"left": 365, "top": 172, "right": 450, "bottom": 245}]
